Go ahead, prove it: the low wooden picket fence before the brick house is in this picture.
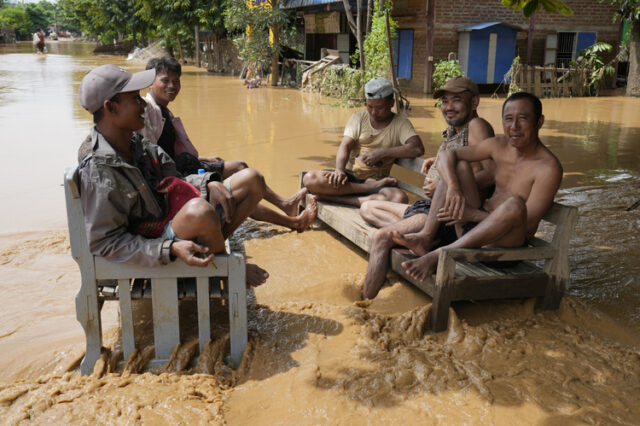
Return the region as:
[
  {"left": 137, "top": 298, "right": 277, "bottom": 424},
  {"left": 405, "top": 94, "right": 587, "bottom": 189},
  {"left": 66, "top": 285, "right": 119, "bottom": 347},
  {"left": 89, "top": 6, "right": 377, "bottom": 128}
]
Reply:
[{"left": 512, "top": 65, "right": 589, "bottom": 98}]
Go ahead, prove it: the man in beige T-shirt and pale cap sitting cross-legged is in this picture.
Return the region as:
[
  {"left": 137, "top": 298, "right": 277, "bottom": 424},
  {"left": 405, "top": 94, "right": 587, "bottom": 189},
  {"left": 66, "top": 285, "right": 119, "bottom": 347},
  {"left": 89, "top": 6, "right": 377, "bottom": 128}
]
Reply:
[{"left": 302, "top": 77, "right": 424, "bottom": 206}]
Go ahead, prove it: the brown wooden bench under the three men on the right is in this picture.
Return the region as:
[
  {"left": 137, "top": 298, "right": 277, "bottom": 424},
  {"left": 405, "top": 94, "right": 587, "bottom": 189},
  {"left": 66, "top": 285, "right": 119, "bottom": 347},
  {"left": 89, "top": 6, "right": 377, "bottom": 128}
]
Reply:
[{"left": 300, "top": 159, "right": 577, "bottom": 331}]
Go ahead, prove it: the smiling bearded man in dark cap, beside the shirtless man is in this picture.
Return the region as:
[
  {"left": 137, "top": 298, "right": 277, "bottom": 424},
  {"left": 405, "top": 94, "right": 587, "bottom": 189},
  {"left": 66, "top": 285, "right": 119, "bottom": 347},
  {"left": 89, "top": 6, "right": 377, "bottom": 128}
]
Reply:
[{"left": 360, "top": 77, "right": 494, "bottom": 299}]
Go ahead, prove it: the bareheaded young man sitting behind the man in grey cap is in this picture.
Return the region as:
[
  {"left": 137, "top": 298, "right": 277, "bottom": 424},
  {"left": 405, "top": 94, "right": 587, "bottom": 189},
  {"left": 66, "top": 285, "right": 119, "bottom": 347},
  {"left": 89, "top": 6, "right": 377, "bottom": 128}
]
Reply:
[{"left": 140, "top": 56, "right": 318, "bottom": 232}]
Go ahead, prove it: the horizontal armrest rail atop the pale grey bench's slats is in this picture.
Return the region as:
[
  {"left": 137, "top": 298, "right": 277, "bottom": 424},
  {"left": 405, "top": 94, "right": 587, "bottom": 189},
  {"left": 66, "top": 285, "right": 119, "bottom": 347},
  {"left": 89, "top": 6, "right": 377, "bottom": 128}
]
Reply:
[{"left": 93, "top": 258, "right": 228, "bottom": 279}]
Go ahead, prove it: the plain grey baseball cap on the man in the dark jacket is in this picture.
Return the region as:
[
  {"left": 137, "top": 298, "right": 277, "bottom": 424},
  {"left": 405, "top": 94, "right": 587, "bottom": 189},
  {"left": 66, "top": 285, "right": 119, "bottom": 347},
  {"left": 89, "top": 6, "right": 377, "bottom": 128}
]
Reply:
[{"left": 78, "top": 64, "right": 156, "bottom": 114}]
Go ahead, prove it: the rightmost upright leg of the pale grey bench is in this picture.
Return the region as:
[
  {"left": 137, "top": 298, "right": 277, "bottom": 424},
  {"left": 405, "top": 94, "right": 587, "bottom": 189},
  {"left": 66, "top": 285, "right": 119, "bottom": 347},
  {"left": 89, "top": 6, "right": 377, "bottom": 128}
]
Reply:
[{"left": 229, "top": 253, "right": 248, "bottom": 367}]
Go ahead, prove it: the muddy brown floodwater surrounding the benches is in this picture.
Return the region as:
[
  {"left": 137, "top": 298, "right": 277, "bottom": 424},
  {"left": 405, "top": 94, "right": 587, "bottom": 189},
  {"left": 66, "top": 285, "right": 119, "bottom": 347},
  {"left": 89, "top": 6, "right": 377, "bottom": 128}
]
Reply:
[{"left": 0, "top": 43, "right": 640, "bottom": 425}]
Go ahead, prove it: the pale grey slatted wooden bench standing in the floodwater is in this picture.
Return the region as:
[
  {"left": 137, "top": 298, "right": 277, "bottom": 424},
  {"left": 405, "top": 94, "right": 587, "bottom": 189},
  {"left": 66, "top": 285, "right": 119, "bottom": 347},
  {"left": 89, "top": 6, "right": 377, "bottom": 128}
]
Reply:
[{"left": 64, "top": 165, "right": 247, "bottom": 374}]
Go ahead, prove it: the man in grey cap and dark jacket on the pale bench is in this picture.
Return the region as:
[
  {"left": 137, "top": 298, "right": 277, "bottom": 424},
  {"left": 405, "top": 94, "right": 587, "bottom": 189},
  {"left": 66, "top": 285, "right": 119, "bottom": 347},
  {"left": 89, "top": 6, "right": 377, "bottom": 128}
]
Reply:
[{"left": 78, "top": 65, "right": 268, "bottom": 285}]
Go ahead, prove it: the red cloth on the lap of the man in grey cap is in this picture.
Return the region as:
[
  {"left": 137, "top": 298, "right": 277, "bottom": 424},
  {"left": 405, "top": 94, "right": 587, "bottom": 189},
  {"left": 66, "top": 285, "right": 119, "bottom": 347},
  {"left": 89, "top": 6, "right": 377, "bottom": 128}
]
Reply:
[{"left": 134, "top": 176, "right": 200, "bottom": 238}]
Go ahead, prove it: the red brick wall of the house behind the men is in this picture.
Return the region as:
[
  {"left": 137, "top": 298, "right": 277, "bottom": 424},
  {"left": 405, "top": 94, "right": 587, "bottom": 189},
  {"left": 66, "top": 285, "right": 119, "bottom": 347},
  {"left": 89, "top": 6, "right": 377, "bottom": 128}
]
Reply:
[{"left": 392, "top": 0, "right": 619, "bottom": 90}]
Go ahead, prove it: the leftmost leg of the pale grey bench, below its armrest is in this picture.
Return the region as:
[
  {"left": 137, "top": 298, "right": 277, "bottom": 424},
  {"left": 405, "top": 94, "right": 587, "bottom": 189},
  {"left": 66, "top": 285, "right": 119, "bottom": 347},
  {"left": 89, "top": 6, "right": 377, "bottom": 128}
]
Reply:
[{"left": 76, "top": 279, "right": 102, "bottom": 375}]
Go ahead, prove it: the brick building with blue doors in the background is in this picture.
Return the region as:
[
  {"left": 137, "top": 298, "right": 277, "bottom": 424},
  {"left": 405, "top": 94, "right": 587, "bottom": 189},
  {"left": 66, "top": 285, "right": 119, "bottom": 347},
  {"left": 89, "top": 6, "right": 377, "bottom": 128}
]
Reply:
[{"left": 280, "top": 0, "right": 621, "bottom": 92}]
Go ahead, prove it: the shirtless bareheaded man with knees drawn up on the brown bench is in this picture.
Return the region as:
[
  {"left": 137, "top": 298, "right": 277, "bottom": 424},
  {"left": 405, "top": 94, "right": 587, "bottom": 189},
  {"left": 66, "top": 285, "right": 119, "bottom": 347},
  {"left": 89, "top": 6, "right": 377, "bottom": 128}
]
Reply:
[{"left": 392, "top": 92, "right": 562, "bottom": 281}]
